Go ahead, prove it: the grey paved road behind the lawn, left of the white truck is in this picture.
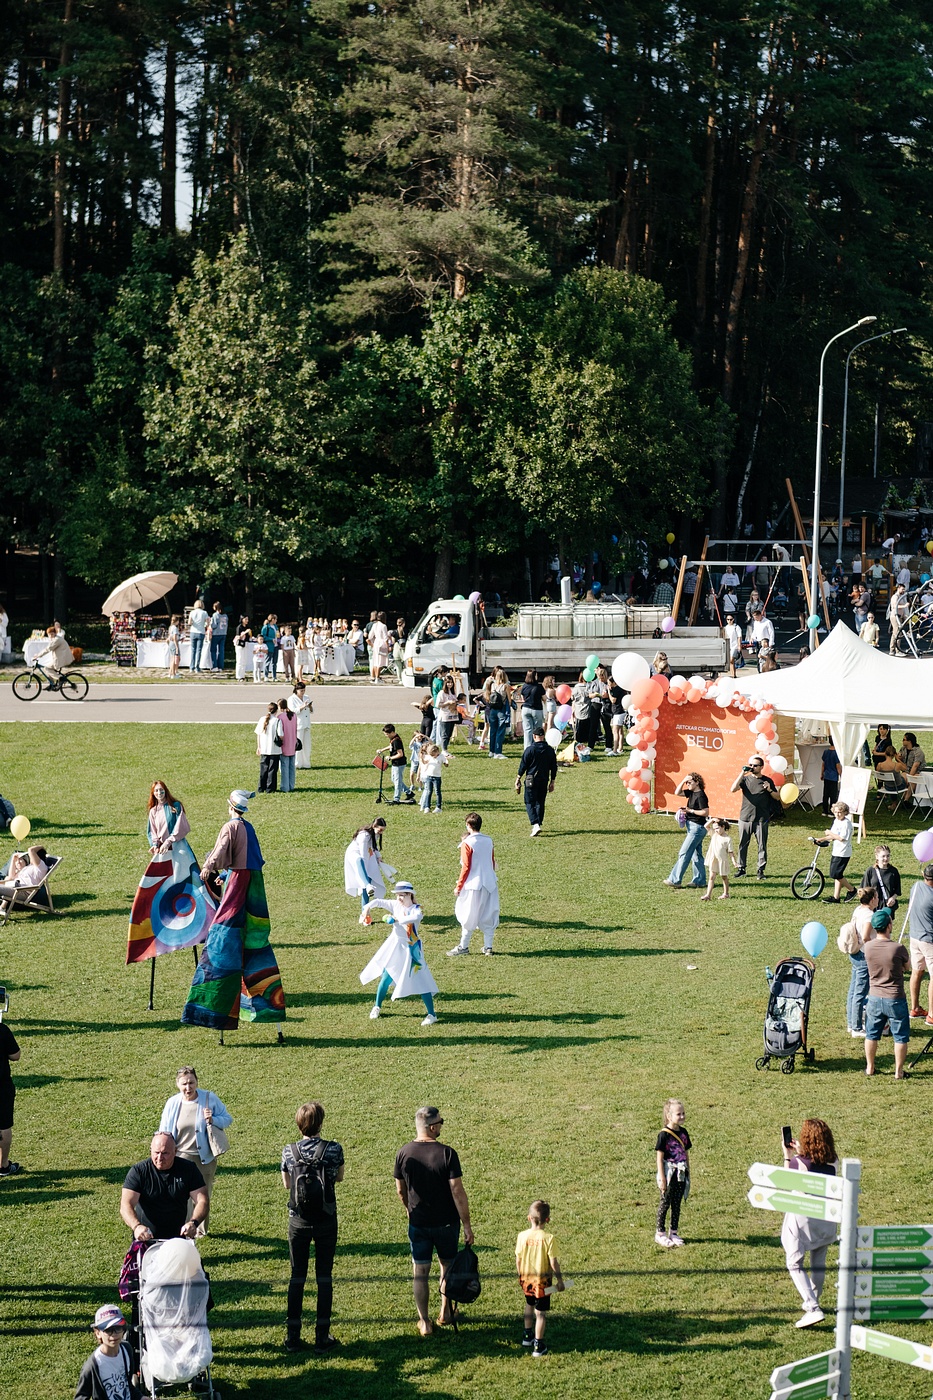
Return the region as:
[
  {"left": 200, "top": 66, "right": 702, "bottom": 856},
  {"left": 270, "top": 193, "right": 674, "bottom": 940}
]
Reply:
[{"left": 0, "top": 680, "right": 419, "bottom": 728}]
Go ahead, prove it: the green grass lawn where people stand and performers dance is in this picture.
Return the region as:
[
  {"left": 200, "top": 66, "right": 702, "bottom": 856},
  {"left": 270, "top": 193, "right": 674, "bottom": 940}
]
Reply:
[{"left": 0, "top": 724, "right": 933, "bottom": 1400}]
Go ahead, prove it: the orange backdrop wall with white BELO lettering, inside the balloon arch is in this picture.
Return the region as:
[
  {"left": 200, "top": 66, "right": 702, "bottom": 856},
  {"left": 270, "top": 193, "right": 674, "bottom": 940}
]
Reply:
[{"left": 654, "top": 700, "right": 794, "bottom": 822}]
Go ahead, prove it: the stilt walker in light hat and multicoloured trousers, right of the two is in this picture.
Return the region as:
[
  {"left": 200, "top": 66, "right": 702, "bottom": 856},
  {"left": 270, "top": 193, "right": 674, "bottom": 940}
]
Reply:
[{"left": 182, "top": 788, "right": 286, "bottom": 1044}]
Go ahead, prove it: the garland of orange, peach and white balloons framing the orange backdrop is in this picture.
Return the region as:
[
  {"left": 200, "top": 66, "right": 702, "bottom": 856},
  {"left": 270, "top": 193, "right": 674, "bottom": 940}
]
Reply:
[{"left": 612, "top": 651, "right": 790, "bottom": 817}]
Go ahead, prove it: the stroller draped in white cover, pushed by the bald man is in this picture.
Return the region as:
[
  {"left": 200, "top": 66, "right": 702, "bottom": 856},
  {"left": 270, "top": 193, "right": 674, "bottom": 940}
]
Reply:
[{"left": 139, "top": 1239, "right": 220, "bottom": 1400}]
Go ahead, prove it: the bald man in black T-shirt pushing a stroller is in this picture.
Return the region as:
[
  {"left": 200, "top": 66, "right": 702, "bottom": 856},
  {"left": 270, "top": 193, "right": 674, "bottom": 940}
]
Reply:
[{"left": 120, "top": 1133, "right": 209, "bottom": 1240}]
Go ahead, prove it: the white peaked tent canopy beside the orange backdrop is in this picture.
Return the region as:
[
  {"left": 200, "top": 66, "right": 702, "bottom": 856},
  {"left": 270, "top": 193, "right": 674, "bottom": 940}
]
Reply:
[{"left": 735, "top": 622, "right": 933, "bottom": 764}]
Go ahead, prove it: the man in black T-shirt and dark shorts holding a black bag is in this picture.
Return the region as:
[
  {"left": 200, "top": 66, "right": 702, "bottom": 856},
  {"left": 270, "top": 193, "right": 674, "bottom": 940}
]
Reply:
[{"left": 395, "top": 1107, "right": 474, "bottom": 1337}]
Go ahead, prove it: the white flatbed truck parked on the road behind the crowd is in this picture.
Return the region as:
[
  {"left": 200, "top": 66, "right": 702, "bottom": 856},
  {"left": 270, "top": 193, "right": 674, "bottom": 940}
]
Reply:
[{"left": 402, "top": 598, "right": 728, "bottom": 686}]
